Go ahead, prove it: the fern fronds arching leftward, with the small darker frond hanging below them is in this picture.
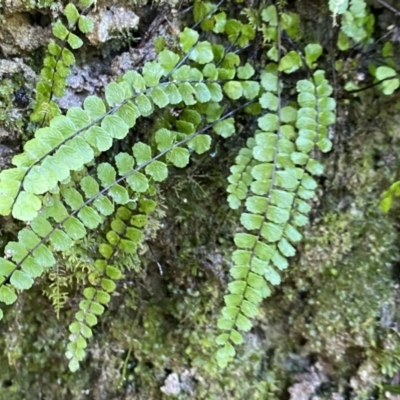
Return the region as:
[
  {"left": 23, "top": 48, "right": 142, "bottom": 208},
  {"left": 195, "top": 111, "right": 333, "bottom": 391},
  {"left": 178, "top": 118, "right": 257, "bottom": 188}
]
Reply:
[{"left": 0, "top": 16, "right": 254, "bottom": 370}]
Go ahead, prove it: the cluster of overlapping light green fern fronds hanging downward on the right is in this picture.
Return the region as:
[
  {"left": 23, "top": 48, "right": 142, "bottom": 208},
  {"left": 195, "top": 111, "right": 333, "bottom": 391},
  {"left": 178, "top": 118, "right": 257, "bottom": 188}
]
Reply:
[{"left": 217, "top": 6, "right": 335, "bottom": 367}]
